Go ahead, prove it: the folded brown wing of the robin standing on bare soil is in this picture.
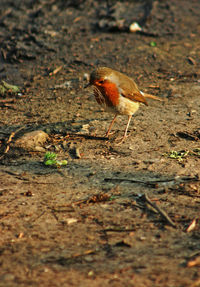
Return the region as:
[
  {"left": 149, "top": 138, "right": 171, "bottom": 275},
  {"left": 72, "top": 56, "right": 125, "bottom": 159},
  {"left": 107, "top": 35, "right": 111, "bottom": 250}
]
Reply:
[{"left": 115, "top": 72, "right": 148, "bottom": 106}]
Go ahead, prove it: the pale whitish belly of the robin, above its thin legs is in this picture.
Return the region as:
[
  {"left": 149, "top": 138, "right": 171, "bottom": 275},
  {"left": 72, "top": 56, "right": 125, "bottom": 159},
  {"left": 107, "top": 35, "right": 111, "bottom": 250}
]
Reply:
[{"left": 117, "top": 95, "right": 140, "bottom": 116}]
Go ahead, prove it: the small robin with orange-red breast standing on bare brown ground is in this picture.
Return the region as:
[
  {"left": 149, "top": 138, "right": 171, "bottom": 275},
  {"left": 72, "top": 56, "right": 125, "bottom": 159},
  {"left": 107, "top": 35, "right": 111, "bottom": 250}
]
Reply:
[{"left": 85, "top": 67, "right": 162, "bottom": 144}]
